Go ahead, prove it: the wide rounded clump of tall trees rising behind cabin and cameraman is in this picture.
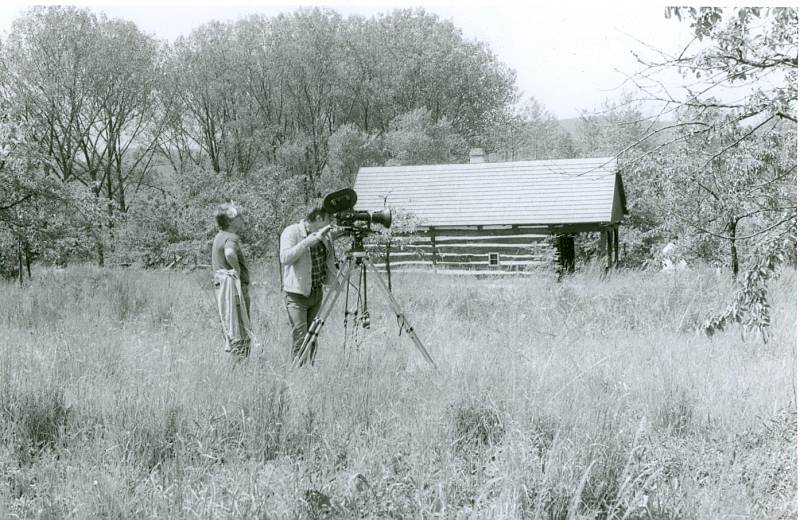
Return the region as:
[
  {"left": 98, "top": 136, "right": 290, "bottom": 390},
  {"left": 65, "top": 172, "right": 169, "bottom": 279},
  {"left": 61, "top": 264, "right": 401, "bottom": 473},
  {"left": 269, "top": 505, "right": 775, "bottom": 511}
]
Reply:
[{"left": 162, "top": 9, "right": 513, "bottom": 180}]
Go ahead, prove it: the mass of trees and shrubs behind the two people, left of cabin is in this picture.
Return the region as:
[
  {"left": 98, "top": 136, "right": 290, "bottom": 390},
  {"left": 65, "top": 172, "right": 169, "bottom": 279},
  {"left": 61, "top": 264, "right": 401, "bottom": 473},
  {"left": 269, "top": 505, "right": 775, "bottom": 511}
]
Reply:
[{"left": 0, "top": 6, "right": 514, "bottom": 265}]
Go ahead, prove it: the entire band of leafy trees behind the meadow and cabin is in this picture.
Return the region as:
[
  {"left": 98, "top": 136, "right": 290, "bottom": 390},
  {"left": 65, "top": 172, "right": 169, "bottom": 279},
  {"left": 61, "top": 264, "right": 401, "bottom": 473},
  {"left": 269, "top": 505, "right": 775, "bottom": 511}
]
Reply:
[{"left": 0, "top": 6, "right": 797, "bottom": 292}]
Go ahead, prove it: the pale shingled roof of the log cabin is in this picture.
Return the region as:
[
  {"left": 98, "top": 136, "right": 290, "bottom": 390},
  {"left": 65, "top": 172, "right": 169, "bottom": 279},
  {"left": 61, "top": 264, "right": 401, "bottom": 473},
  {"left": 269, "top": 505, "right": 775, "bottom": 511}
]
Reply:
[{"left": 355, "top": 157, "right": 628, "bottom": 226}]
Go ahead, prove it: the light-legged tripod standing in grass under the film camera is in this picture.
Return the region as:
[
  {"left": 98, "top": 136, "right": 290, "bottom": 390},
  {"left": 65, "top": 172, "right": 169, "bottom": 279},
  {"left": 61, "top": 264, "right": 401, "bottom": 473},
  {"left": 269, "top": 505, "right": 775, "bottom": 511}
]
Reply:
[{"left": 292, "top": 232, "right": 437, "bottom": 368}]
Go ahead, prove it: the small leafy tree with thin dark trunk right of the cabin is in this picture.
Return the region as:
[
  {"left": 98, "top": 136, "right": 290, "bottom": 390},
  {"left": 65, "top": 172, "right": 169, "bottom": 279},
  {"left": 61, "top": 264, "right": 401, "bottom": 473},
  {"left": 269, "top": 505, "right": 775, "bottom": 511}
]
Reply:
[{"left": 657, "top": 109, "right": 797, "bottom": 278}]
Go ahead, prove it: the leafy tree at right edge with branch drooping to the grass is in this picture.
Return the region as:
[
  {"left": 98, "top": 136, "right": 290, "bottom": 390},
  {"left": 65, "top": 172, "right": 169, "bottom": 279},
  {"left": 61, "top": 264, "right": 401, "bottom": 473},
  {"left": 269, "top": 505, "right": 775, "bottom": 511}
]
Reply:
[{"left": 633, "top": 7, "right": 798, "bottom": 339}]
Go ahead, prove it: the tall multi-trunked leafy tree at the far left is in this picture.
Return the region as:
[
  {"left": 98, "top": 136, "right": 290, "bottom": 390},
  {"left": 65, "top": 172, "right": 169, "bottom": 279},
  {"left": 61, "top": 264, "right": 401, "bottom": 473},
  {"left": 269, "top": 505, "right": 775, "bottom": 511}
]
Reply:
[{"left": 0, "top": 7, "right": 164, "bottom": 265}]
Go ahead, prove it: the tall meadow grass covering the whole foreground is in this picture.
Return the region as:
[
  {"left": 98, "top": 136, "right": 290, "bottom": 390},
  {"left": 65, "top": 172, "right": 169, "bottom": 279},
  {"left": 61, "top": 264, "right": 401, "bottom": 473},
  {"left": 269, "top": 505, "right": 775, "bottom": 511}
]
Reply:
[{"left": 0, "top": 267, "right": 797, "bottom": 519}]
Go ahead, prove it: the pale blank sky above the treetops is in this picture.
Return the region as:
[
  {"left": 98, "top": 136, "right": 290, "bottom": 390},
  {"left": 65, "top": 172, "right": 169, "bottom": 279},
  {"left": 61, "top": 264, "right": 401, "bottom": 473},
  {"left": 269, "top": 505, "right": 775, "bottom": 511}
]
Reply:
[{"left": 0, "top": 0, "right": 720, "bottom": 119}]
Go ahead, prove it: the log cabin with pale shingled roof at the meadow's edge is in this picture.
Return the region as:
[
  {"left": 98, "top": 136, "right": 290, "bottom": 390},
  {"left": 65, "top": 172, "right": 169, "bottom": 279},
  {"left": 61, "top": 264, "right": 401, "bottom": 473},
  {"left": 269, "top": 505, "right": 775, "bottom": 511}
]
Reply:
[{"left": 354, "top": 149, "right": 628, "bottom": 274}]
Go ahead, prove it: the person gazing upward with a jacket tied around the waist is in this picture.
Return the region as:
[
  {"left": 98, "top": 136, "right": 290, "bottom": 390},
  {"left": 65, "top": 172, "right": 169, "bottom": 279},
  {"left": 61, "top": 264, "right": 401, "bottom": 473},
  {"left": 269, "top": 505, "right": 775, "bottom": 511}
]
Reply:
[{"left": 211, "top": 203, "right": 252, "bottom": 359}]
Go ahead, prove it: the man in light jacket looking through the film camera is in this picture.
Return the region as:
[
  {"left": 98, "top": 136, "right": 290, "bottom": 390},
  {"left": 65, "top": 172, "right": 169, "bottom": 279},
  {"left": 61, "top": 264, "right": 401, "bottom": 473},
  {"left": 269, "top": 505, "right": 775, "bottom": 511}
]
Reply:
[{"left": 280, "top": 205, "right": 336, "bottom": 365}]
